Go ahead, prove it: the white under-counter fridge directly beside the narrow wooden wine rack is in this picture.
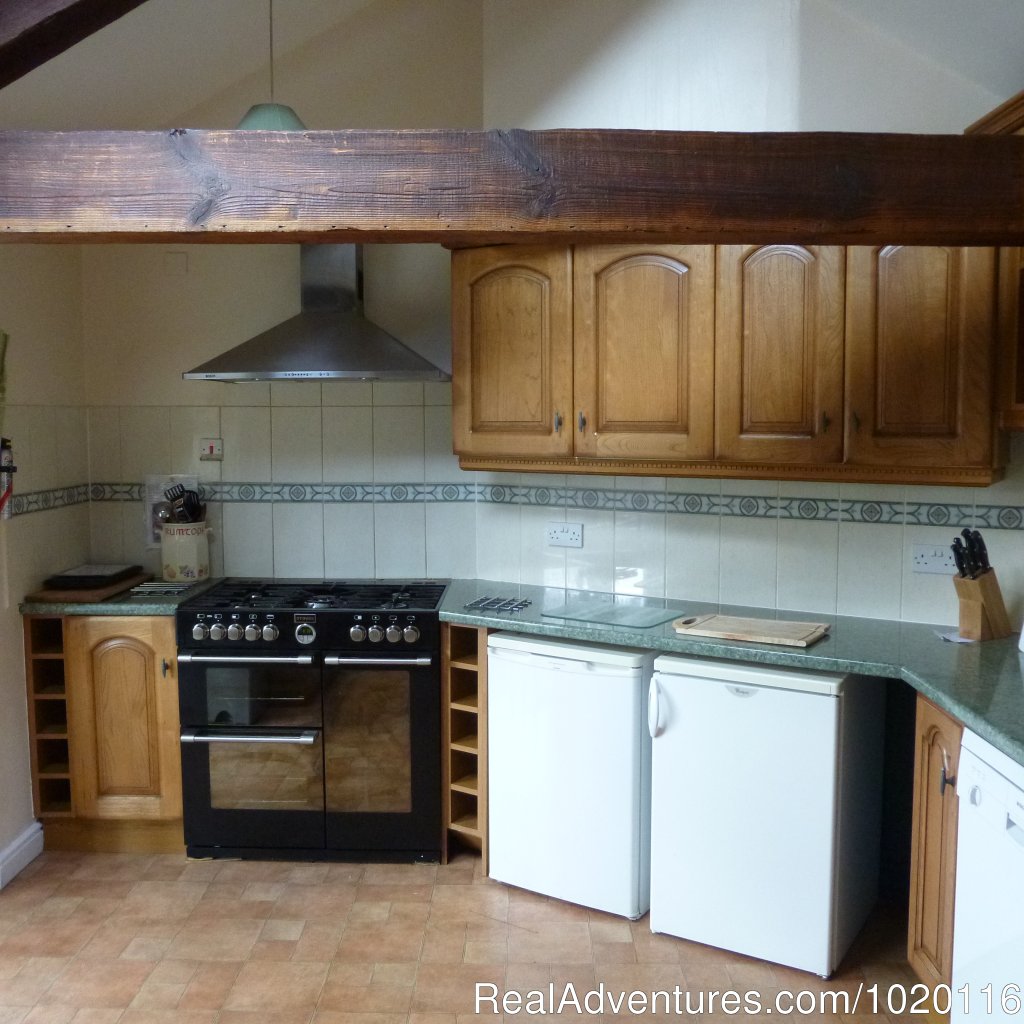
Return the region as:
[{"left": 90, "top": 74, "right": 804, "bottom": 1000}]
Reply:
[{"left": 487, "top": 633, "right": 654, "bottom": 919}]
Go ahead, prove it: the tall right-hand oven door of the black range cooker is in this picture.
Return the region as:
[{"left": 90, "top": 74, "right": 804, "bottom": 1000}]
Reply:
[{"left": 324, "top": 654, "right": 441, "bottom": 859}]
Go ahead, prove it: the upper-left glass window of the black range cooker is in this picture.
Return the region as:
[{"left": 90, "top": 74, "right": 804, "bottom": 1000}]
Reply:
[{"left": 205, "top": 664, "right": 321, "bottom": 728}]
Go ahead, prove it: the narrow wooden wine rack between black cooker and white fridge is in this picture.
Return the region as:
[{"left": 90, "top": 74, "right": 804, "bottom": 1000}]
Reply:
[{"left": 441, "top": 623, "right": 487, "bottom": 874}]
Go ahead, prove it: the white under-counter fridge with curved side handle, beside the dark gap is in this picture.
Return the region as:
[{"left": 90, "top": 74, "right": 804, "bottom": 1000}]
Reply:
[{"left": 648, "top": 656, "right": 885, "bottom": 977}]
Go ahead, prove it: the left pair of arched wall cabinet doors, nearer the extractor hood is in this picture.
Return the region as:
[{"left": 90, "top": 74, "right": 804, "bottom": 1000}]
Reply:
[{"left": 452, "top": 246, "right": 715, "bottom": 460}]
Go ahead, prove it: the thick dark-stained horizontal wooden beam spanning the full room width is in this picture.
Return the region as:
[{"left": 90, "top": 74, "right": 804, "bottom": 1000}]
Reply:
[{"left": 0, "top": 129, "right": 1024, "bottom": 246}]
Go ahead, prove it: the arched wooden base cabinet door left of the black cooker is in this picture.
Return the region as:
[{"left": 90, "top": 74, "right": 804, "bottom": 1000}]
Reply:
[{"left": 67, "top": 615, "right": 181, "bottom": 819}]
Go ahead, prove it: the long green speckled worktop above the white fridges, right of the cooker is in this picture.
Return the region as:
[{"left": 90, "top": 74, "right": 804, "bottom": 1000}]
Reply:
[{"left": 441, "top": 580, "right": 1024, "bottom": 764}]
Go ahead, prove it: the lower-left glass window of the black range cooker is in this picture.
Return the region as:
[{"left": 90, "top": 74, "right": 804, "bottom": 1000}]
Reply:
[{"left": 209, "top": 735, "right": 324, "bottom": 811}]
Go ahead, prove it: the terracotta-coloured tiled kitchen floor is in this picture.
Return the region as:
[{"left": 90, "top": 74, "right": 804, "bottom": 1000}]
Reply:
[{"left": 0, "top": 853, "right": 921, "bottom": 1024}]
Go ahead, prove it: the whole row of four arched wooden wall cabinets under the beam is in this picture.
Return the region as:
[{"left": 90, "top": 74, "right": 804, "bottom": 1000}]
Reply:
[{"left": 453, "top": 245, "right": 999, "bottom": 484}]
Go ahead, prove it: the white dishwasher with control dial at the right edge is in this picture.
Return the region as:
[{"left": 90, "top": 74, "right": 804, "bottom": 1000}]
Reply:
[{"left": 940, "top": 729, "right": 1024, "bottom": 1024}]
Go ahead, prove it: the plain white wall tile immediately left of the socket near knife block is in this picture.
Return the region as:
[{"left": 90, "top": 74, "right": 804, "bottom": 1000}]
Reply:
[{"left": 836, "top": 524, "right": 903, "bottom": 618}]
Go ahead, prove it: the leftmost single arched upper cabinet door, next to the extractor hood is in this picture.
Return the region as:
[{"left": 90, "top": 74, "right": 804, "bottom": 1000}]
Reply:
[{"left": 452, "top": 246, "right": 572, "bottom": 459}]
